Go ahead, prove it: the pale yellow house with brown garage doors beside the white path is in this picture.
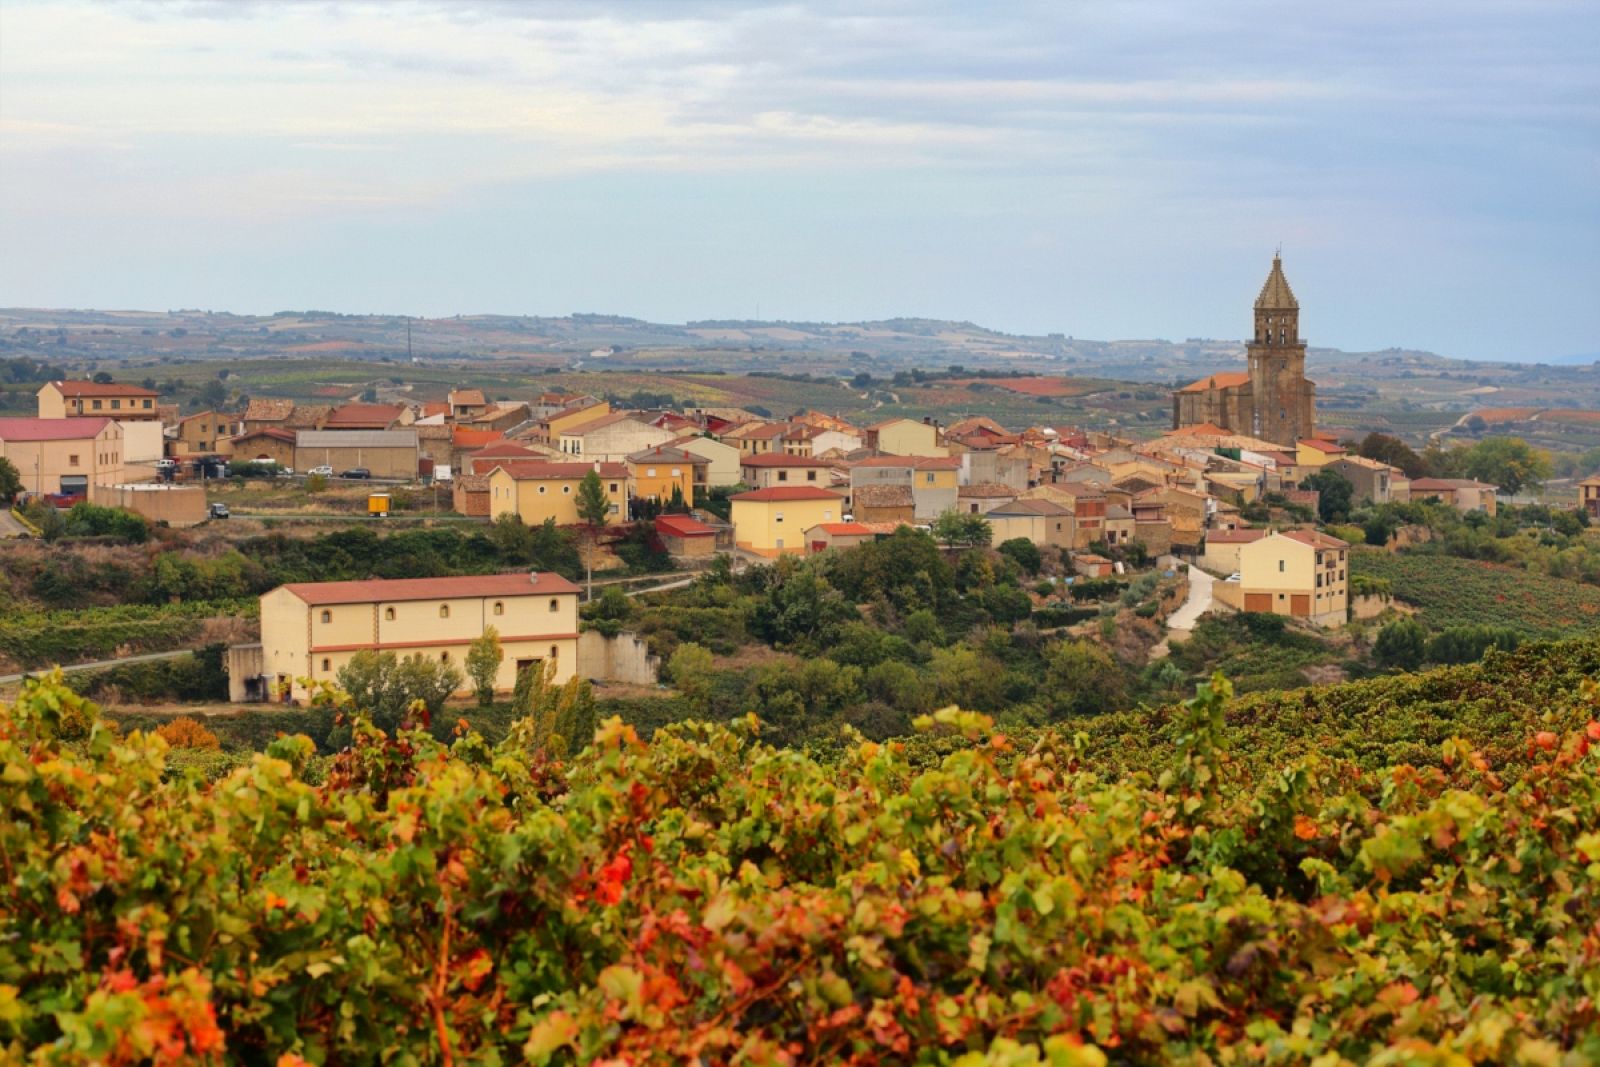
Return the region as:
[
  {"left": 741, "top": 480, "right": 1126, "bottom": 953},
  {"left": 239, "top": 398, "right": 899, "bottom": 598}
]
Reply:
[{"left": 1238, "top": 530, "right": 1350, "bottom": 625}]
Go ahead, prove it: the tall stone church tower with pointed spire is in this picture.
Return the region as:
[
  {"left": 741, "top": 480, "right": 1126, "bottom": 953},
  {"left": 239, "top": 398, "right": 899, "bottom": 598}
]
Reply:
[{"left": 1245, "top": 256, "right": 1317, "bottom": 448}]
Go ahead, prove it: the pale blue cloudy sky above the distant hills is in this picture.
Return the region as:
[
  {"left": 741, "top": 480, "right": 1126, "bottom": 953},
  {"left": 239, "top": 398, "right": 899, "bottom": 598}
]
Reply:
[{"left": 0, "top": 0, "right": 1600, "bottom": 360}]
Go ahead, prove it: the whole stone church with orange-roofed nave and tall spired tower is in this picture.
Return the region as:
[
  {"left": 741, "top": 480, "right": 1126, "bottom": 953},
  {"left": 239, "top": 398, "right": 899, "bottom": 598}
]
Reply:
[{"left": 1173, "top": 256, "right": 1317, "bottom": 448}]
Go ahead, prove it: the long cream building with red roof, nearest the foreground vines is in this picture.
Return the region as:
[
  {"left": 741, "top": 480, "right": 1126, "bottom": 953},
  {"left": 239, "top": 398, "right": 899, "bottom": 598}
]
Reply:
[{"left": 261, "top": 573, "right": 578, "bottom": 701}]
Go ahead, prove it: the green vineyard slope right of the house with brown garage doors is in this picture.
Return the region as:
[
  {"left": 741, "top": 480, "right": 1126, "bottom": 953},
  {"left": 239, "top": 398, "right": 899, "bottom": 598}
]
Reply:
[{"left": 1350, "top": 552, "right": 1600, "bottom": 637}]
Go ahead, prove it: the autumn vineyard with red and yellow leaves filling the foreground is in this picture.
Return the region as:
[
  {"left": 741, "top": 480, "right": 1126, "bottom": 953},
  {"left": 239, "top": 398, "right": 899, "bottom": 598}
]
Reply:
[{"left": 0, "top": 641, "right": 1600, "bottom": 1067}]
